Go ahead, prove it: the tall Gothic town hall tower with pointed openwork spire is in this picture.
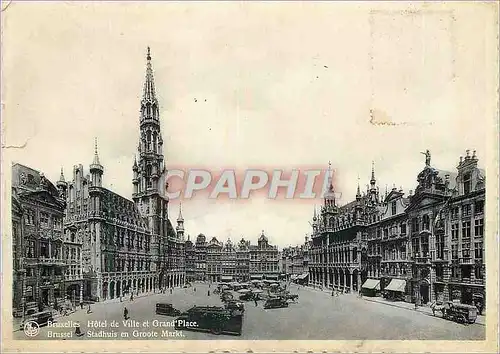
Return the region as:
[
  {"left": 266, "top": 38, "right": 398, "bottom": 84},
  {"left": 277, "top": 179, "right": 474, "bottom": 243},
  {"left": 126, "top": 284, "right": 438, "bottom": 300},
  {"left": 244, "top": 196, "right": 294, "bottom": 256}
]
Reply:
[{"left": 132, "top": 47, "right": 169, "bottom": 284}]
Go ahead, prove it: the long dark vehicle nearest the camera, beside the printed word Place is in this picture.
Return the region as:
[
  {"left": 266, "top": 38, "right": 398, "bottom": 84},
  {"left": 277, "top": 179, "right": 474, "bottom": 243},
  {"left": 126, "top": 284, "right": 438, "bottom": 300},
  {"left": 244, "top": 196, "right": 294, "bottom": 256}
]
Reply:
[{"left": 175, "top": 306, "right": 243, "bottom": 335}]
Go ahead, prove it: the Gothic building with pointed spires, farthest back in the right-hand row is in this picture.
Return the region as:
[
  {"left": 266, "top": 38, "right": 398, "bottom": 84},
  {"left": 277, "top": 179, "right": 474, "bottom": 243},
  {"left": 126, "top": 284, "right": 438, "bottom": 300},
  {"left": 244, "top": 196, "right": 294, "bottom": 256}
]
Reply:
[{"left": 309, "top": 166, "right": 380, "bottom": 292}]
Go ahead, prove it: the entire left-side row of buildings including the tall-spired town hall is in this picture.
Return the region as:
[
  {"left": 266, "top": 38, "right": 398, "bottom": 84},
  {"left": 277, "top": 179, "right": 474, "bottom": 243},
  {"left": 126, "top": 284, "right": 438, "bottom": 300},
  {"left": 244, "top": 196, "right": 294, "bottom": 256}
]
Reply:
[{"left": 12, "top": 48, "right": 185, "bottom": 316}]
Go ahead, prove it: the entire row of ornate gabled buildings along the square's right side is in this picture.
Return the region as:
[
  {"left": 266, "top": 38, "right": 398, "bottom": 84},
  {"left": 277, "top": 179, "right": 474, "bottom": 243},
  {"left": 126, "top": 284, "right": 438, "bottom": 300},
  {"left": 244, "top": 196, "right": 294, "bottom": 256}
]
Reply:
[{"left": 309, "top": 150, "right": 485, "bottom": 305}]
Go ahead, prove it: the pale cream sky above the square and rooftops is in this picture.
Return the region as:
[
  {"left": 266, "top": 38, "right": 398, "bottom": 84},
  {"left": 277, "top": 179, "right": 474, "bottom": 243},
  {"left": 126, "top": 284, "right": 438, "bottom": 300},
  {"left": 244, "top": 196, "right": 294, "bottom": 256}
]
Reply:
[{"left": 2, "top": 2, "right": 497, "bottom": 247}]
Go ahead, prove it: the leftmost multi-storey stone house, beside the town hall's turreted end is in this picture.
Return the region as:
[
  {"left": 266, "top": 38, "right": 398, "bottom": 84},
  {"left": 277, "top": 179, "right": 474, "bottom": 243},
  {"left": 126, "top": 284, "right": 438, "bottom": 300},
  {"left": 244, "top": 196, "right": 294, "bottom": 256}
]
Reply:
[{"left": 12, "top": 164, "right": 66, "bottom": 316}]
